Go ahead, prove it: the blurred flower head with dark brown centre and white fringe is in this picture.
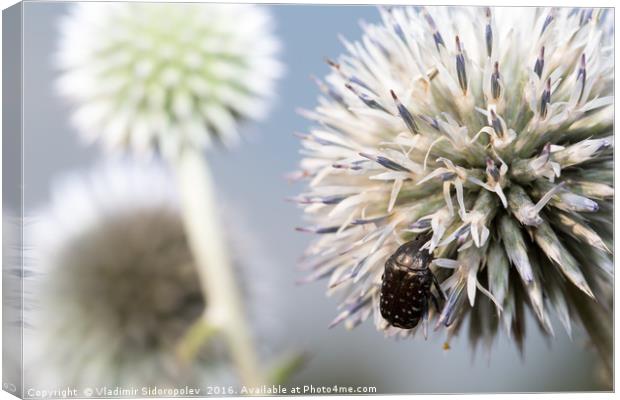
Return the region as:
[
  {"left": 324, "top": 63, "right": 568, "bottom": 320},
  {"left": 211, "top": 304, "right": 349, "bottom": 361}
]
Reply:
[{"left": 26, "top": 160, "right": 275, "bottom": 387}]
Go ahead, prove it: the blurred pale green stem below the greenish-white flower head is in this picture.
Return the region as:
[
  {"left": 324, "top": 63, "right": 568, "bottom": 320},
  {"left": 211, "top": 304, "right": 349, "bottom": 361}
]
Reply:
[{"left": 175, "top": 148, "right": 265, "bottom": 386}]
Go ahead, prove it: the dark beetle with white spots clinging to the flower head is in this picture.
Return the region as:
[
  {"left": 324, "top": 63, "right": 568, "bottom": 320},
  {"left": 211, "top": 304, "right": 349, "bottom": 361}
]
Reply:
[{"left": 379, "top": 235, "right": 443, "bottom": 329}]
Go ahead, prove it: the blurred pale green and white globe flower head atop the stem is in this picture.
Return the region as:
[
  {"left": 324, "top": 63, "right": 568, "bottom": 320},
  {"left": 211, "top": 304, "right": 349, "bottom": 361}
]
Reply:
[{"left": 57, "top": 2, "right": 282, "bottom": 155}]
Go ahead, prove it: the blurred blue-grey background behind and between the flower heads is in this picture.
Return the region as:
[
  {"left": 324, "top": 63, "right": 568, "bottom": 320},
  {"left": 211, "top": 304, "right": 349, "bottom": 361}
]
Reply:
[{"left": 24, "top": 2, "right": 603, "bottom": 393}]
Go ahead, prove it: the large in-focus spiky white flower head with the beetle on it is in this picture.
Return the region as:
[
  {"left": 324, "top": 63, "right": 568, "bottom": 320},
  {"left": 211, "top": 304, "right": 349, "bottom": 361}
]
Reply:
[{"left": 296, "top": 7, "right": 613, "bottom": 354}]
